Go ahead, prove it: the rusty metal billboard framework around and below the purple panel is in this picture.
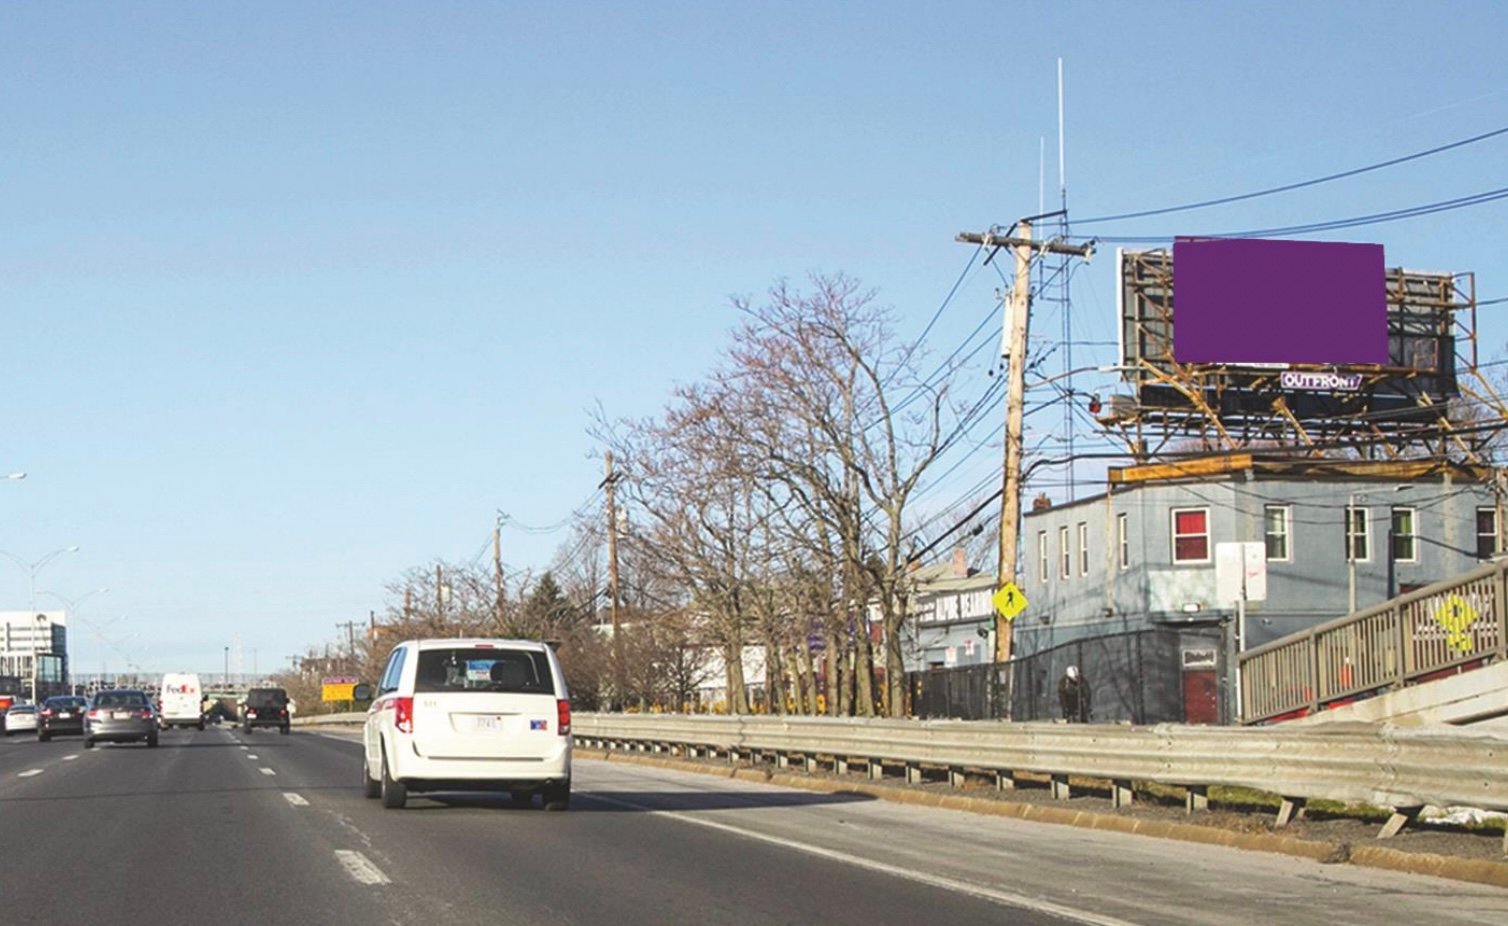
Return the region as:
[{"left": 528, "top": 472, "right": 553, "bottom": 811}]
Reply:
[{"left": 1099, "top": 249, "right": 1489, "bottom": 465}]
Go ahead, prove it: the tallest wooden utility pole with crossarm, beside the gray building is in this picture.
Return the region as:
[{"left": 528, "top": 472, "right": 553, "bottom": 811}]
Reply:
[{"left": 956, "top": 220, "right": 1095, "bottom": 664}]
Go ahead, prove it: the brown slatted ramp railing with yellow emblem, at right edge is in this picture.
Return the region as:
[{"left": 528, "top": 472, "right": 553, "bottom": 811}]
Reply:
[{"left": 1241, "top": 560, "right": 1508, "bottom": 724}]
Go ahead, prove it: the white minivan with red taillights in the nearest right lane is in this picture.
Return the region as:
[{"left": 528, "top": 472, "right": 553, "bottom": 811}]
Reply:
[{"left": 357, "top": 638, "right": 572, "bottom": 810}]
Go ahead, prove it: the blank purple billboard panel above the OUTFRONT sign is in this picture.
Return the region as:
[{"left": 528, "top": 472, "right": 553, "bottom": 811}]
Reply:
[{"left": 1173, "top": 238, "right": 1387, "bottom": 365}]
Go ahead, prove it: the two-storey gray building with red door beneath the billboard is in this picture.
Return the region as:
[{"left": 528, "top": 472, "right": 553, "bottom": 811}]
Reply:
[{"left": 1013, "top": 454, "right": 1500, "bottom": 722}]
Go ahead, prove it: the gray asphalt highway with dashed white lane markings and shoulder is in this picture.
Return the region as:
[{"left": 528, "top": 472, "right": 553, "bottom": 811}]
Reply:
[{"left": 0, "top": 728, "right": 1508, "bottom": 926}]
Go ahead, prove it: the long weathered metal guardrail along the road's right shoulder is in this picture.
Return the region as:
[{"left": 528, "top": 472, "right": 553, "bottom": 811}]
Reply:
[{"left": 572, "top": 713, "right": 1508, "bottom": 842}]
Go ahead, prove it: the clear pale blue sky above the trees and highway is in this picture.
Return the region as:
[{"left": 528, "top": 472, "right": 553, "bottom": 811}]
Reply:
[{"left": 0, "top": 2, "right": 1508, "bottom": 671}]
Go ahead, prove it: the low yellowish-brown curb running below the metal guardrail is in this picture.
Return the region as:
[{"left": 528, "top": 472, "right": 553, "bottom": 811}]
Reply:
[{"left": 575, "top": 747, "right": 1508, "bottom": 888}]
